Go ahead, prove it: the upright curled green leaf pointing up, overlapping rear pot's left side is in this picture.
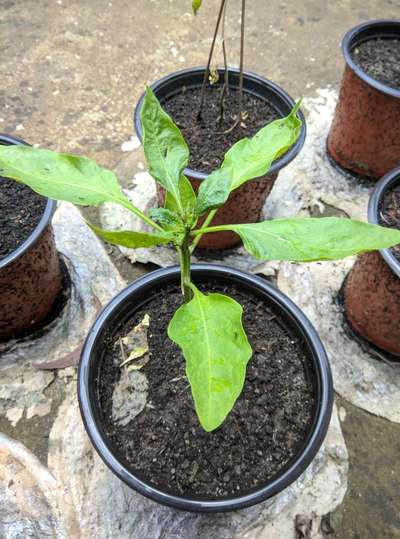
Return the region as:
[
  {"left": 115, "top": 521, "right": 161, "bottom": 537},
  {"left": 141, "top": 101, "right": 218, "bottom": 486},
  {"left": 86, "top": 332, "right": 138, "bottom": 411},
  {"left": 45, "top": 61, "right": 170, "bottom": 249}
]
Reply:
[{"left": 140, "top": 88, "right": 189, "bottom": 214}]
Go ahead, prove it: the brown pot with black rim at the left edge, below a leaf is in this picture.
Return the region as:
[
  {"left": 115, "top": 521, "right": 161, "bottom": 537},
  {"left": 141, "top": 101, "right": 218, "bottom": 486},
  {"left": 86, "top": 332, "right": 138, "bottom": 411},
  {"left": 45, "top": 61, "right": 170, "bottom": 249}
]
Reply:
[{"left": 0, "top": 135, "right": 62, "bottom": 341}]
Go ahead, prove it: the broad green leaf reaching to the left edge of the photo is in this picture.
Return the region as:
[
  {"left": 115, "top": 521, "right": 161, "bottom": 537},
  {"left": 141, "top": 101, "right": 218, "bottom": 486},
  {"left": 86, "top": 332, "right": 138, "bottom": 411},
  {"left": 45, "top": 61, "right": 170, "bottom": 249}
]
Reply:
[{"left": 0, "top": 146, "right": 131, "bottom": 207}]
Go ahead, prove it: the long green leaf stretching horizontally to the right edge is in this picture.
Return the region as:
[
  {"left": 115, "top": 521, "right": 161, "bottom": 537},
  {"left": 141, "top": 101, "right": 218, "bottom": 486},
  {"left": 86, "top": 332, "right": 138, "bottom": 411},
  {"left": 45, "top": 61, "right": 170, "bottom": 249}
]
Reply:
[{"left": 203, "top": 217, "right": 400, "bottom": 262}]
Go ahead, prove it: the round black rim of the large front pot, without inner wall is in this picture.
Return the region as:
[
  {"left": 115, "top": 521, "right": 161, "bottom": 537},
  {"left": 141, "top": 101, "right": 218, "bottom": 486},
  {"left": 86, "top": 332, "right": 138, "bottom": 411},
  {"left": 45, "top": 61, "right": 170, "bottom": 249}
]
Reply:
[{"left": 78, "top": 264, "right": 333, "bottom": 513}]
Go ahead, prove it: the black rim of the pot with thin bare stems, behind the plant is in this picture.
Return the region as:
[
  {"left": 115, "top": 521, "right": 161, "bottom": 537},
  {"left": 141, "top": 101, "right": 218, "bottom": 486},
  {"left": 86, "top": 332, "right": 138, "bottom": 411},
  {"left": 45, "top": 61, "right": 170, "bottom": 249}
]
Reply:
[{"left": 134, "top": 66, "right": 307, "bottom": 181}]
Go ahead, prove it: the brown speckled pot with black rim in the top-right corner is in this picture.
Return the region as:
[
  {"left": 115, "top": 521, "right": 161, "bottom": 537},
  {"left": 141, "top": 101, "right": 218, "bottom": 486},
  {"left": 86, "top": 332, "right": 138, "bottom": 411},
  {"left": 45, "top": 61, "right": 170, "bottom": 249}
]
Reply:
[{"left": 327, "top": 20, "right": 400, "bottom": 179}]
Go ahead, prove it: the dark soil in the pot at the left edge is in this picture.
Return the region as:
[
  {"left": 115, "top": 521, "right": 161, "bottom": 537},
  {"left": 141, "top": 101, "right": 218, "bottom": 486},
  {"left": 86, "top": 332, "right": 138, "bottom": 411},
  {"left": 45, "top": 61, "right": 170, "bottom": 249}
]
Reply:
[{"left": 0, "top": 177, "right": 47, "bottom": 260}]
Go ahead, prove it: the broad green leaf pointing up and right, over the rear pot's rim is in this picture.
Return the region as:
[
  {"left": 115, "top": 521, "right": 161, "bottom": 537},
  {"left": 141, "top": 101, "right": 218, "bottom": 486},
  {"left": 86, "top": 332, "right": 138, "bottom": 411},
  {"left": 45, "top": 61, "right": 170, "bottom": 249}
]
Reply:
[{"left": 197, "top": 102, "right": 302, "bottom": 215}]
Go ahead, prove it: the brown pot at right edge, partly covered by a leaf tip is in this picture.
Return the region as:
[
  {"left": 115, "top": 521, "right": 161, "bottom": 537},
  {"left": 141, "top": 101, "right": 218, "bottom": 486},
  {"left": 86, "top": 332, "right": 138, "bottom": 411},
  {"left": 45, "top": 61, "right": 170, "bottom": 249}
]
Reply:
[{"left": 344, "top": 168, "right": 400, "bottom": 356}]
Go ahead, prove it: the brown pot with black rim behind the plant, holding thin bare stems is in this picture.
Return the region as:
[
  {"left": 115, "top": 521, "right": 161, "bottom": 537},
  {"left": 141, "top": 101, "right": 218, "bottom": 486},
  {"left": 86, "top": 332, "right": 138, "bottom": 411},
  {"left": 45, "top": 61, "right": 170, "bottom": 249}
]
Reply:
[{"left": 134, "top": 67, "right": 306, "bottom": 249}]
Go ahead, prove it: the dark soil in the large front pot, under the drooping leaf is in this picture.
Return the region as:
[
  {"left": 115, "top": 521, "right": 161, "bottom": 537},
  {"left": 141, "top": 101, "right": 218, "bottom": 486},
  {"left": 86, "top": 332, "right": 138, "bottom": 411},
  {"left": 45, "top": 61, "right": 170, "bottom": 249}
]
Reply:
[{"left": 98, "top": 284, "right": 315, "bottom": 498}]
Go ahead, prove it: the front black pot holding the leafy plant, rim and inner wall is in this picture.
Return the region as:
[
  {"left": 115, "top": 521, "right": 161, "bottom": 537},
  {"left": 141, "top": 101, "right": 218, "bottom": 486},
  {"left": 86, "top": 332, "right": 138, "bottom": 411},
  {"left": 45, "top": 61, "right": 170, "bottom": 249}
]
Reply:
[{"left": 78, "top": 264, "right": 333, "bottom": 513}]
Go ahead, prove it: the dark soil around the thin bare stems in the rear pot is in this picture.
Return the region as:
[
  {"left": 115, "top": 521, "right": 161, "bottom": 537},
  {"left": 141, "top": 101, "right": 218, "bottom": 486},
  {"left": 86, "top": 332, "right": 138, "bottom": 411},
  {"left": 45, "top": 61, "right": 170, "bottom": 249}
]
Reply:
[{"left": 163, "top": 86, "right": 282, "bottom": 173}]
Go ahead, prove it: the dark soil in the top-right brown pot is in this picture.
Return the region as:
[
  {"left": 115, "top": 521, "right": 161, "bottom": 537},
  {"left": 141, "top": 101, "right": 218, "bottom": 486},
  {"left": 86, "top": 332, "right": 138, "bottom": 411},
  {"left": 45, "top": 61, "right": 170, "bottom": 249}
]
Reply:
[{"left": 351, "top": 39, "right": 400, "bottom": 90}]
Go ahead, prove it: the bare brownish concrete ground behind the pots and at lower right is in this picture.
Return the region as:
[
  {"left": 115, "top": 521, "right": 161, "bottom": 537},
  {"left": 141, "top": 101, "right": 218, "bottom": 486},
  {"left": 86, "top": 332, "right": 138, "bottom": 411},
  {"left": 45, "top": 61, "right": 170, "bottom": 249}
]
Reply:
[{"left": 0, "top": 0, "right": 400, "bottom": 539}]
